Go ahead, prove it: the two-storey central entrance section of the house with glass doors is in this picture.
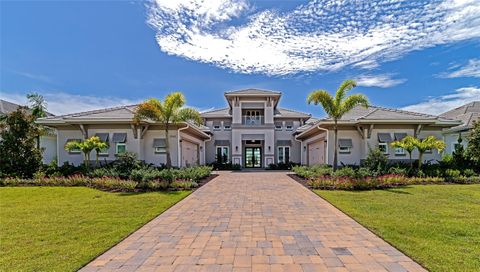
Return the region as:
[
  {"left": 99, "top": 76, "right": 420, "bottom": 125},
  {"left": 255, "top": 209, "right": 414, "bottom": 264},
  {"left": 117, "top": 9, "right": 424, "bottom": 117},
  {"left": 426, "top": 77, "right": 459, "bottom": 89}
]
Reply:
[{"left": 202, "top": 89, "right": 311, "bottom": 168}]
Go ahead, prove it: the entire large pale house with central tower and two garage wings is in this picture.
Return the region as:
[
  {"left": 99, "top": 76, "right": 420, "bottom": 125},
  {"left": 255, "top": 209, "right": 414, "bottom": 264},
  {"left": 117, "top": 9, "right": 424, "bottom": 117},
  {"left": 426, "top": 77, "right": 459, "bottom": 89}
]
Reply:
[{"left": 38, "top": 89, "right": 461, "bottom": 168}]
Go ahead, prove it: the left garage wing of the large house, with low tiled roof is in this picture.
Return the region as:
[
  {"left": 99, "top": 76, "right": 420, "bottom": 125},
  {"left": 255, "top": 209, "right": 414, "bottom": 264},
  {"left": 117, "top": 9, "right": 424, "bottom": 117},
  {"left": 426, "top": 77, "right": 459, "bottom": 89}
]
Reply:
[{"left": 37, "top": 105, "right": 211, "bottom": 167}]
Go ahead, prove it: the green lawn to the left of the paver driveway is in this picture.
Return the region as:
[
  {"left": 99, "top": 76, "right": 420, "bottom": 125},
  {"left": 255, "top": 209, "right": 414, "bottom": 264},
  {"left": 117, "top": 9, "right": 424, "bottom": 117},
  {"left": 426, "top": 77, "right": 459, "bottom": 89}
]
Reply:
[{"left": 0, "top": 187, "right": 189, "bottom": 271}]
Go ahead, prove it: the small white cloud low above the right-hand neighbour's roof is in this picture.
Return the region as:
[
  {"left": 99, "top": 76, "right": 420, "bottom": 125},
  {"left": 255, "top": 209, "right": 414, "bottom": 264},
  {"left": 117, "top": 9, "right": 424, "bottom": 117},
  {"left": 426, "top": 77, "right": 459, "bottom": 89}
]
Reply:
[{"left": 403, "top": 87, "right": 480, "bottom": 114}]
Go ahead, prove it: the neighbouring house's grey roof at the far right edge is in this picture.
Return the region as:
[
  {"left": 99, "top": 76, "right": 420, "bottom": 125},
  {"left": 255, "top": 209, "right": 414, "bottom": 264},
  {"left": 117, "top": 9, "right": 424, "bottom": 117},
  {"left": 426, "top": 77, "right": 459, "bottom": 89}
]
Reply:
[{"left": 440, "top": 101, "right": 480, "bottom": 131}]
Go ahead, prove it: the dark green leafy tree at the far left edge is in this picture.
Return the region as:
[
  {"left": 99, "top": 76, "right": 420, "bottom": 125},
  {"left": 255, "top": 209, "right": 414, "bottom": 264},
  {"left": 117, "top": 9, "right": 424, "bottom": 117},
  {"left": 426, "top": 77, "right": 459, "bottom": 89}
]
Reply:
[{"left": 0, "top": 107, "right": 42, "bottom": 178}]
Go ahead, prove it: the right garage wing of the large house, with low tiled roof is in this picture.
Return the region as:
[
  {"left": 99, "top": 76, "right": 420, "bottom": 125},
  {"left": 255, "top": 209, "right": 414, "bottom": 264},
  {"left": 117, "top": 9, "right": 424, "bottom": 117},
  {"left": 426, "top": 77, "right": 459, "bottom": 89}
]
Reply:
[{"left": 296, "top": 103, "right": 460, "bottom": 165}]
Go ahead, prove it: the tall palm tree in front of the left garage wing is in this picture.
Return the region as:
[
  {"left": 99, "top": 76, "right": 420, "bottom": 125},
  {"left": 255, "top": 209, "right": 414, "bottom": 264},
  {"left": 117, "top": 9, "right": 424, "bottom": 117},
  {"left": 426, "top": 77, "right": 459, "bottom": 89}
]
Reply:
[{"left": 134, "top": 92, "right": 202, "bottom": 167}]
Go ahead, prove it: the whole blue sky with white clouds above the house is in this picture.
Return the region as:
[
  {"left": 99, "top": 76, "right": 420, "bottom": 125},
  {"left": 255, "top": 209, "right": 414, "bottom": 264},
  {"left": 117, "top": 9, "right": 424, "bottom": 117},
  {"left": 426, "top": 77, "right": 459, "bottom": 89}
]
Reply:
[{"left": 0, "top": 0, "right": 480, "bottom": 116}]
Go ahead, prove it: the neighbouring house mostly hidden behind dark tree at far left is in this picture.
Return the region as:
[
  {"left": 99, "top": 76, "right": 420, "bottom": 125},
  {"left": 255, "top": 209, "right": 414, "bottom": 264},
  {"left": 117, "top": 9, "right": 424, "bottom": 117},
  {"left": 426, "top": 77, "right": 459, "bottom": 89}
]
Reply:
[{"left": 0, "top": 99, "right": 57, "bottom": 164}]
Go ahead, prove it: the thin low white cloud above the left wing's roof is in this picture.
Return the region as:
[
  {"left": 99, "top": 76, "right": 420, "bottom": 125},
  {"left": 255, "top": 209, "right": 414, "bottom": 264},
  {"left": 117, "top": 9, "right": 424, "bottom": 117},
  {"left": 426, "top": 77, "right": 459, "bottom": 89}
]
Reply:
[{"left": 0, "top": 91, "right": 141, "bottom": 115}]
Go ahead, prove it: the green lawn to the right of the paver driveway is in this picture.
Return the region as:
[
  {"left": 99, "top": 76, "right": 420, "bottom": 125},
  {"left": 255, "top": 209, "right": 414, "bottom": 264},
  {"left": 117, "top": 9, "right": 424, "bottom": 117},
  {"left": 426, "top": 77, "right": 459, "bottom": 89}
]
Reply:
[{"left": 315, "top": 184, "right": 480, "bottom": 271}]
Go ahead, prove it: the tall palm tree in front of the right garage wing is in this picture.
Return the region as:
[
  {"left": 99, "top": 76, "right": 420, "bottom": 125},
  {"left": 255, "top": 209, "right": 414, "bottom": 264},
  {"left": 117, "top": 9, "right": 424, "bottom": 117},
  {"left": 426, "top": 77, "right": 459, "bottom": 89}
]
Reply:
[{"left": 307, "top": 80, "right": 368, "bottom": 170}]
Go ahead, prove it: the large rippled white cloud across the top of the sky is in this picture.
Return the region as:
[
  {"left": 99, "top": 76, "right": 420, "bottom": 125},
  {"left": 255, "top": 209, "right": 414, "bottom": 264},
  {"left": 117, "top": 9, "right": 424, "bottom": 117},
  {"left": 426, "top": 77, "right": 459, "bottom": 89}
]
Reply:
[{"left": 147, "top": 0, "right": 480, "bottom": 75}]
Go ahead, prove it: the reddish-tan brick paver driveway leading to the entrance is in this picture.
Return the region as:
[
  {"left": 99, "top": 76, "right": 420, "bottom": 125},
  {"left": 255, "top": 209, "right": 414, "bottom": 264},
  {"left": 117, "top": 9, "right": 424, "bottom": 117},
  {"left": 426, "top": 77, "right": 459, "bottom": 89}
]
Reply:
[{"left": 83, "top": 172, "right": 423, "bottom": 271}]
